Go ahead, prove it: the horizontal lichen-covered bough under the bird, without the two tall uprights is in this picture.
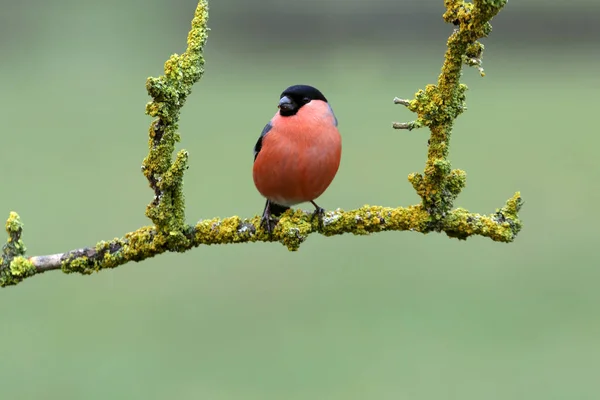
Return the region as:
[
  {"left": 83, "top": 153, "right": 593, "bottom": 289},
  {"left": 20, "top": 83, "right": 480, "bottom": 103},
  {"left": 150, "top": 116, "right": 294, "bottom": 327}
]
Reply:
[{"left": 0, "top": 193, "right": 521, "bottom": 286}]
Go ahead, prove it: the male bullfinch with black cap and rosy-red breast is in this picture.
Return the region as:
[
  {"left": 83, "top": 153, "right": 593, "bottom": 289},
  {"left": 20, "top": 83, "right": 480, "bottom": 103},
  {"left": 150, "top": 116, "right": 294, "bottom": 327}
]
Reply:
[{"left": 252, "top": 85, "right": 342, "bottom": 233}]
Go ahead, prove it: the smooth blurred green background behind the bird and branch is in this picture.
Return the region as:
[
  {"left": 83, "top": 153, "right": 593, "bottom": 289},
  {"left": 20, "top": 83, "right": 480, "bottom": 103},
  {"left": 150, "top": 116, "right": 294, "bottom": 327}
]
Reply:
[{"left": 0, "top": 0, "right": 600, "bottom": 400}]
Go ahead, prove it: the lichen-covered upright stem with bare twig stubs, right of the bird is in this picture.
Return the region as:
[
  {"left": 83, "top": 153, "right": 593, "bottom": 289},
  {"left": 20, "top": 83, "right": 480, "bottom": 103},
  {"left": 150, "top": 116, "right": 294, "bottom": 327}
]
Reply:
[{"left": 392, "top": 0, "right": 521, "bottom": 231}]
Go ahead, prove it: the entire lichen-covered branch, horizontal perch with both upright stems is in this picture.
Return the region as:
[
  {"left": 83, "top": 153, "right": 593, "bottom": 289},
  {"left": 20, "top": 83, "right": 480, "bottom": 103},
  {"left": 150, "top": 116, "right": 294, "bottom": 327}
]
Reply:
[{"left": 0, "top": 0, "right": 522, "bottom": 287}]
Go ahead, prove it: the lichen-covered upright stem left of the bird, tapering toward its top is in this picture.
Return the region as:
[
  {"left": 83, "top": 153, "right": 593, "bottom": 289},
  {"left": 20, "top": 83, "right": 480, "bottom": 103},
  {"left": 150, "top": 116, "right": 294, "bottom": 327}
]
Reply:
[{"left": 142, "top": 0, "right": 208, "bottom": 238}]
